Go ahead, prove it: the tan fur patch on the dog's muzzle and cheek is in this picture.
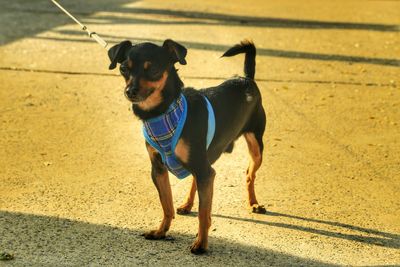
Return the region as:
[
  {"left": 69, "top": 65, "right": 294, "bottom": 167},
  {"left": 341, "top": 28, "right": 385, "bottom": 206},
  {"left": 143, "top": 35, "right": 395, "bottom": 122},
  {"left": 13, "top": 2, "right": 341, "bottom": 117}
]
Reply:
[{"left": 138, "top": 71, "right": 168, "bottom": 110}]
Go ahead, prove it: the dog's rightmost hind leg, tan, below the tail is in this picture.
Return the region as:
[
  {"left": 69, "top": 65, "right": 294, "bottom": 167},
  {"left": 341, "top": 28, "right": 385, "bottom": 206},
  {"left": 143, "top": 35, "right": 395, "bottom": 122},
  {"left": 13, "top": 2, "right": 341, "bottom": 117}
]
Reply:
[{"left": 244, "top": 132, "right": 266, "bottom": 213}]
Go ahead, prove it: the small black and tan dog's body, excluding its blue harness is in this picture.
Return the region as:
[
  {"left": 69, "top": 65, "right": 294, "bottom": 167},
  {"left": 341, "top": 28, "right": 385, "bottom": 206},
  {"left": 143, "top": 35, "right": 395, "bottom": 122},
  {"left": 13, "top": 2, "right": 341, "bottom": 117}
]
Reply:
[{"left": 108, "top": 40, "right": 266, "bottom": 254}]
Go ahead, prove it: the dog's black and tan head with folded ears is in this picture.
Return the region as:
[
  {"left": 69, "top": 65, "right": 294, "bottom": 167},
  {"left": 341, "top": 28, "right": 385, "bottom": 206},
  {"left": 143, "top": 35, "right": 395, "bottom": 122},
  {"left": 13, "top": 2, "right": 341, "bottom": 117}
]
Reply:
[{"left": 108, "top": 39, "right": 187, "bottom": 110}]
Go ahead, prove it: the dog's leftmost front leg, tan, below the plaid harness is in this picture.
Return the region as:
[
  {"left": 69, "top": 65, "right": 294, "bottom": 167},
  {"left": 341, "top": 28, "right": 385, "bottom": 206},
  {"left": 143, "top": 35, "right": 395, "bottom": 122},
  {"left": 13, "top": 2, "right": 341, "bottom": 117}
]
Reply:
[{"left": 144, "top": 143, "right": 175, "bottom": 239}]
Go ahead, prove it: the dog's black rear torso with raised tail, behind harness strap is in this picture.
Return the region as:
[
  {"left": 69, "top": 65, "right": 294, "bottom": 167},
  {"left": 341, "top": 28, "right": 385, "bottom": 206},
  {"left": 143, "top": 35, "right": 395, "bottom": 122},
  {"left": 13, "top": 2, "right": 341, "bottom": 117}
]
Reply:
[{"left": 194, "top": 41, "right": 266, "bottom": 163}]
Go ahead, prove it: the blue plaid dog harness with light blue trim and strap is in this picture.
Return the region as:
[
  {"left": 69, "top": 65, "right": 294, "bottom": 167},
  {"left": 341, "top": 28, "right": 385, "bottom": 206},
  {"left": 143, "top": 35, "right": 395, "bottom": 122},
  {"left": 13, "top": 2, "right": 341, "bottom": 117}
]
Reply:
[{"left": 143, "top": 94, "right": 215, "bottom": 179}]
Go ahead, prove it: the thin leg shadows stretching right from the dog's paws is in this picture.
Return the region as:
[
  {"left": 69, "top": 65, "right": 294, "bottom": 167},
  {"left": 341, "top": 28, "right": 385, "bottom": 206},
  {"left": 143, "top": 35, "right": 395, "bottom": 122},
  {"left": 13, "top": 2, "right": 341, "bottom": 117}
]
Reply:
[{"left": 185, "top": 212, "right": 400, "bottom": 249}]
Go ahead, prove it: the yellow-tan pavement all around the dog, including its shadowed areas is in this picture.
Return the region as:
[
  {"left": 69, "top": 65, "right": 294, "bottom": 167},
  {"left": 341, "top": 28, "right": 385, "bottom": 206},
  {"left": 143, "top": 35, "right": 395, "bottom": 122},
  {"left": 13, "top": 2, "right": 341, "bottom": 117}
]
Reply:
[{"left": 0, "top": 0, "right": 400, "bottom": 266}]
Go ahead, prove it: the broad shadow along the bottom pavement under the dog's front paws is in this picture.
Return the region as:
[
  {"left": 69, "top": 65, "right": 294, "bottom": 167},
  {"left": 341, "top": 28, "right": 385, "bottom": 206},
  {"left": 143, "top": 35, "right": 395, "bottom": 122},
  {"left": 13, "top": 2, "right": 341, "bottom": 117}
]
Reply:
[{"left": 0, "top": 211, "right": 333, "bottom": 266}]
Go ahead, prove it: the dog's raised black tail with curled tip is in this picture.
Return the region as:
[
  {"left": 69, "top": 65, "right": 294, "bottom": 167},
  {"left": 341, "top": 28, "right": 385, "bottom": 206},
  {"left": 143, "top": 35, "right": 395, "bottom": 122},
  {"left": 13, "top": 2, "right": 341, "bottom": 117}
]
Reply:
[{"left": 222, "top": 40, "right": 256, "bottom": 80}]
